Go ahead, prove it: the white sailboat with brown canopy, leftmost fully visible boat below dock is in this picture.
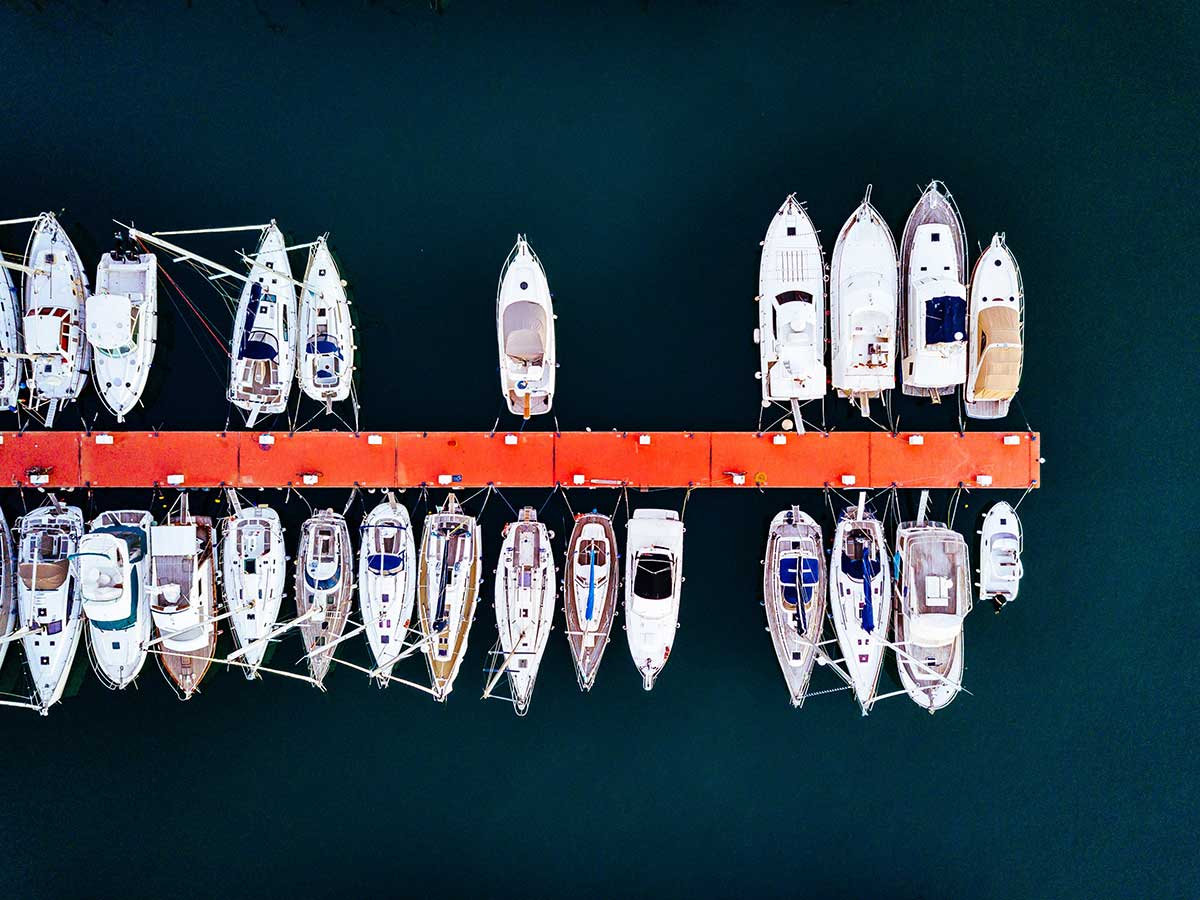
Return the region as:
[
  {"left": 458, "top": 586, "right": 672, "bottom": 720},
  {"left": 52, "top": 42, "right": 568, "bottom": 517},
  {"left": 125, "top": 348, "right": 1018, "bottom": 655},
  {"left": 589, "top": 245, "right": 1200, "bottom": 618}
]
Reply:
[{"left": 17, "top": 498, "right": 83, "bottom": 715}]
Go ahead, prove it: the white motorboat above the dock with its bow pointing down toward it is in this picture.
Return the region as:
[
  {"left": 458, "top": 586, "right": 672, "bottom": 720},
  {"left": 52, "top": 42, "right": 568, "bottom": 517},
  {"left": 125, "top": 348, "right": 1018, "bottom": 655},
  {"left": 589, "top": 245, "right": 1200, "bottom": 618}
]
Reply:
[{"left": 86, "top": 250, "right": 158, "bottom": 422}]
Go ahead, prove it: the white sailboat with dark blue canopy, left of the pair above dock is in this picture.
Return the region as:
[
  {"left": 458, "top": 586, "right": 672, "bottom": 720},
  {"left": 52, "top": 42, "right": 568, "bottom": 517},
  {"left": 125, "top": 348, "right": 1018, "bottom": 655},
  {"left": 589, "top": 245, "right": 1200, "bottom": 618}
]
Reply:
[{"left": 228, "top": 221, "right": 296, "bottom": 427}]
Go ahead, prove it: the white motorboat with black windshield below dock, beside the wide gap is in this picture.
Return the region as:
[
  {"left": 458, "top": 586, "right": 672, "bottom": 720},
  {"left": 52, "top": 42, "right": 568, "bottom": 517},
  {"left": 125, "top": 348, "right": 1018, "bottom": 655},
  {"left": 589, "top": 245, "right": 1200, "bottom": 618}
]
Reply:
[{"left": 625, "top": 509, "right": 684, "bottom": 690}]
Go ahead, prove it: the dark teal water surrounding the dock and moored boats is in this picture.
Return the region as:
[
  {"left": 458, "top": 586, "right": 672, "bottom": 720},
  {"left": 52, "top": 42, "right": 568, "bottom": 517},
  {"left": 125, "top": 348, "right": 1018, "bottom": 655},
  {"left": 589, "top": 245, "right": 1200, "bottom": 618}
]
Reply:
[{"left": 0, "top": 0, "right": 1200, "bottom": 898}]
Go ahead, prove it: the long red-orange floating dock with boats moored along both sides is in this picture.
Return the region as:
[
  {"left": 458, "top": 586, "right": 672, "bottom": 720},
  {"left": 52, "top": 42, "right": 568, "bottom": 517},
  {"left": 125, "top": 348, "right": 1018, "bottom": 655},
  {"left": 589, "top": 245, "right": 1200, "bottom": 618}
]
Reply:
[{"left": 0, "top": 431, "right": 1040, "bottom": 488}]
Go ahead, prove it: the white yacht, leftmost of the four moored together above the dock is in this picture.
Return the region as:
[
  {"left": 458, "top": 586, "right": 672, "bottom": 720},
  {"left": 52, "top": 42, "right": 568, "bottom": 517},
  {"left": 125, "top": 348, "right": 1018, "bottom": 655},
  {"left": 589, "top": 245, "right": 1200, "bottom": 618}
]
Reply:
[{"left": 755, "top": 194, "right": 826, "bottom": 412}]
